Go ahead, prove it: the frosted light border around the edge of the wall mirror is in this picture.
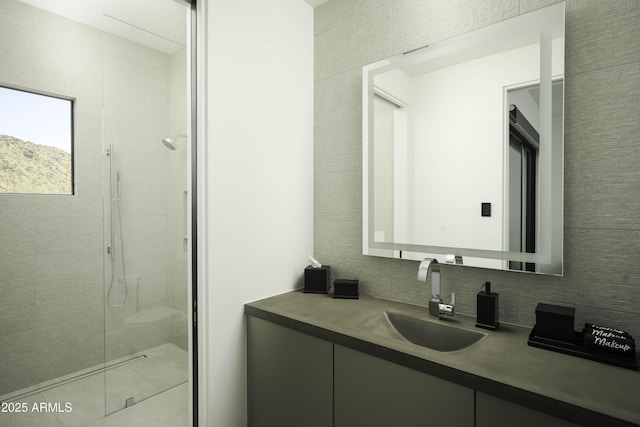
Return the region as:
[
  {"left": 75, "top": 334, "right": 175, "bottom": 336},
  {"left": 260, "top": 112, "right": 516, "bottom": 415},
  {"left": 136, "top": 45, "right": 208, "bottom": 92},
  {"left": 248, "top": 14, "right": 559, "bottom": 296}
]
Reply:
[{"left": 362, "top": 3, "right": 564, "bottom": 275}]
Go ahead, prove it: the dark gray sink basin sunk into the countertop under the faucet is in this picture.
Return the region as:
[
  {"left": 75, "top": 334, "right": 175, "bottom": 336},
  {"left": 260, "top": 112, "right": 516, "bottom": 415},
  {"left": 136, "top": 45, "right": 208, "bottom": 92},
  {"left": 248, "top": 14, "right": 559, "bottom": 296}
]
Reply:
[{"left": 384, "top": 311, "right": 487, "bottom": 352}]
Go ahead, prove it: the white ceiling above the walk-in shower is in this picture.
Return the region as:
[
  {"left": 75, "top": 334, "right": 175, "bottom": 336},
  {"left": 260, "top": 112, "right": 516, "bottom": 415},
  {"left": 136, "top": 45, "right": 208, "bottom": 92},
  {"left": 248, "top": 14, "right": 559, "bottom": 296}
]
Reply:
[{"left": 20, "top": 0, "right": 189, "bottom": 53}]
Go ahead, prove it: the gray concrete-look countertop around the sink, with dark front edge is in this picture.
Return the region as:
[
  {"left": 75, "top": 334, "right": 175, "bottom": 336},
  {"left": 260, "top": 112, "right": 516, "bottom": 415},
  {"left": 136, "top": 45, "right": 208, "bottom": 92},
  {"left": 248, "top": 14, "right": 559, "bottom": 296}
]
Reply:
[{"left": 245, "top": 291, "right": 640, "bottom": 426}]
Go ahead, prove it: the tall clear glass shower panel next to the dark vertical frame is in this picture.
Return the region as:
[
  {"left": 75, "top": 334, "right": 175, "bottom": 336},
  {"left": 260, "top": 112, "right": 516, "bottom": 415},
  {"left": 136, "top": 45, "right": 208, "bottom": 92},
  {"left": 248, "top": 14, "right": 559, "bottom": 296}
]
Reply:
[{"left": 102, "top": 10, "right": 189, "bottom": 414}]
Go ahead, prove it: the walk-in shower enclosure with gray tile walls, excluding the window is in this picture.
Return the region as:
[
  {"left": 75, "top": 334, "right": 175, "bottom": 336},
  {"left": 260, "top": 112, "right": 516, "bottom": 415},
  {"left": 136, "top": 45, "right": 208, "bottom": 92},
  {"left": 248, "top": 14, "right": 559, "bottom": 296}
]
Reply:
[{"left": 0, "top": 0, "right": 190, "bottom": 426}]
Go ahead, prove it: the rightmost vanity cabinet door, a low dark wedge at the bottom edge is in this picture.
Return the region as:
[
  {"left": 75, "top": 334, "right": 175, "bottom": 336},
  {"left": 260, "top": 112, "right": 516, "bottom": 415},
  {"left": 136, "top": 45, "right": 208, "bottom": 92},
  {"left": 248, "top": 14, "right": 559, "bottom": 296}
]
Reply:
[{"left": 476, "top": 391, "right": 579, "bottom": 427}]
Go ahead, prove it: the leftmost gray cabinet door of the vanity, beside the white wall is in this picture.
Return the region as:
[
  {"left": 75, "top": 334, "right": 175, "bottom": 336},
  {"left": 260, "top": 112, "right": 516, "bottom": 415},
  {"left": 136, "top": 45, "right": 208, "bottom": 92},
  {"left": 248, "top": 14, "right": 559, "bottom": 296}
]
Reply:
[{"left": 247, "top": 316, "right": 333, "bottom": 427}]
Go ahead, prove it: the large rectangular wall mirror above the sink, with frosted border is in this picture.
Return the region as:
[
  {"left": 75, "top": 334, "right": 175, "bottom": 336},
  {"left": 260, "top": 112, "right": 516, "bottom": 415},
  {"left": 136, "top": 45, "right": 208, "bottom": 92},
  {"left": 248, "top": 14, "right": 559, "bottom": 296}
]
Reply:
[{"left": 363, "top": 3, "right": 564, "bottom": 275}]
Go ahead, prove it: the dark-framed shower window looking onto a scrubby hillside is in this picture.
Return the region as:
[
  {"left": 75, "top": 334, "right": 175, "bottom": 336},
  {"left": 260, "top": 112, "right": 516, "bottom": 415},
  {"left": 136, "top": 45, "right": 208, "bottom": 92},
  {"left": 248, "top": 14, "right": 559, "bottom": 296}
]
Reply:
[{"left": 0, "top": 86, "right": 74, "bottom": 194}]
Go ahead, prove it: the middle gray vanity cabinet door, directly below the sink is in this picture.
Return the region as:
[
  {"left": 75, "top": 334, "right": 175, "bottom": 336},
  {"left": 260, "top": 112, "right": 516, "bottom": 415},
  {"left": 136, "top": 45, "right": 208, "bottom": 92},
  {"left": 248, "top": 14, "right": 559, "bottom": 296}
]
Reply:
[{"left": 334, "top": 344, "right": 474, "bottom": 427}]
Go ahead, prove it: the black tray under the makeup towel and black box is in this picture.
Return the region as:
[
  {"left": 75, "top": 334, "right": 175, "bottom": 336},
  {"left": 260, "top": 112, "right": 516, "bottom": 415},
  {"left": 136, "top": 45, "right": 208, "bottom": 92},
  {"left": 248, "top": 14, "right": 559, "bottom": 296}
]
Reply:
[{"left": 528, "top": 326, "right": 638, "bottom": 371}]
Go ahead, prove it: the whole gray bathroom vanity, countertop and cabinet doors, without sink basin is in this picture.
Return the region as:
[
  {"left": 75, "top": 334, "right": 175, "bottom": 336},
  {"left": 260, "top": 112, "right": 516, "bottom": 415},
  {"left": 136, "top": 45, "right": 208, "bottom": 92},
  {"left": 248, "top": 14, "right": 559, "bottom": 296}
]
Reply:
[{"left": 245, "top": 291, "right": 640, "bottom": 427}]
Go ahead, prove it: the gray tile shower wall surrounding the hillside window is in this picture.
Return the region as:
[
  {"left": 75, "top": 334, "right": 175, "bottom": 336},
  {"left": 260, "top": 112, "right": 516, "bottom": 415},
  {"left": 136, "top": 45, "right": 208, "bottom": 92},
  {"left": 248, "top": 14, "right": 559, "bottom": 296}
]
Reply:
[{"left": 0, "top": 0, "right": 104, "bottom": 395}]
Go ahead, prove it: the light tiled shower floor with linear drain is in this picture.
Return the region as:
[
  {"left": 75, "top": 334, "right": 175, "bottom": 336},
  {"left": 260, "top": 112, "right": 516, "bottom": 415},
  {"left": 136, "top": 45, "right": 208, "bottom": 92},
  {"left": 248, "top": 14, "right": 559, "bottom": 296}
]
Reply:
[{"left": 0, "top": 344, "right": 189, "bottom": 427}]
